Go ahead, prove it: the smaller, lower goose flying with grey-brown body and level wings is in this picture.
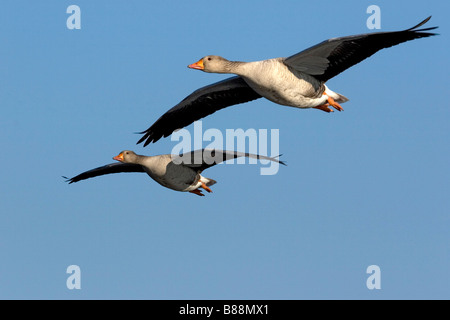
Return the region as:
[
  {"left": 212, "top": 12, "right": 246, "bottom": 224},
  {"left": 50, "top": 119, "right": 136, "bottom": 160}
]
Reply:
[{"left": 63, "top": 149, "right": 286, "bottom": 196}]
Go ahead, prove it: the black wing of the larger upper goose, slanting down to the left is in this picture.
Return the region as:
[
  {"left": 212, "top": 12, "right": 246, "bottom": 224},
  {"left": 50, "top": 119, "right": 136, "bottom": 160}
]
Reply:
[{"left": 138, "top": 76, "right": 261, "bottom": 147}]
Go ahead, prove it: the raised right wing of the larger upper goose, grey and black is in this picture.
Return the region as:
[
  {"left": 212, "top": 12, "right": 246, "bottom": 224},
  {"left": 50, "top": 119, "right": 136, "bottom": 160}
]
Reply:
[{"left": 284, "top": 16, "right": 437, "bottom": 82}]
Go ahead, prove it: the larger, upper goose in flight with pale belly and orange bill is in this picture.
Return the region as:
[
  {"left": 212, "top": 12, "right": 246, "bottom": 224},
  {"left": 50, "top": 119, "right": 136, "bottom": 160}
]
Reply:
[{"left": 137, "top": 16, "right": 437, "bottom": 147}]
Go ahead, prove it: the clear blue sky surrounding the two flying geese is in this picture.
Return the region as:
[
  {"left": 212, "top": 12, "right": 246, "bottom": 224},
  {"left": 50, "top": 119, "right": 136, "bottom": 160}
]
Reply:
[{"left": 0, "top": 0, "right": 450, "bottom": 299}]
